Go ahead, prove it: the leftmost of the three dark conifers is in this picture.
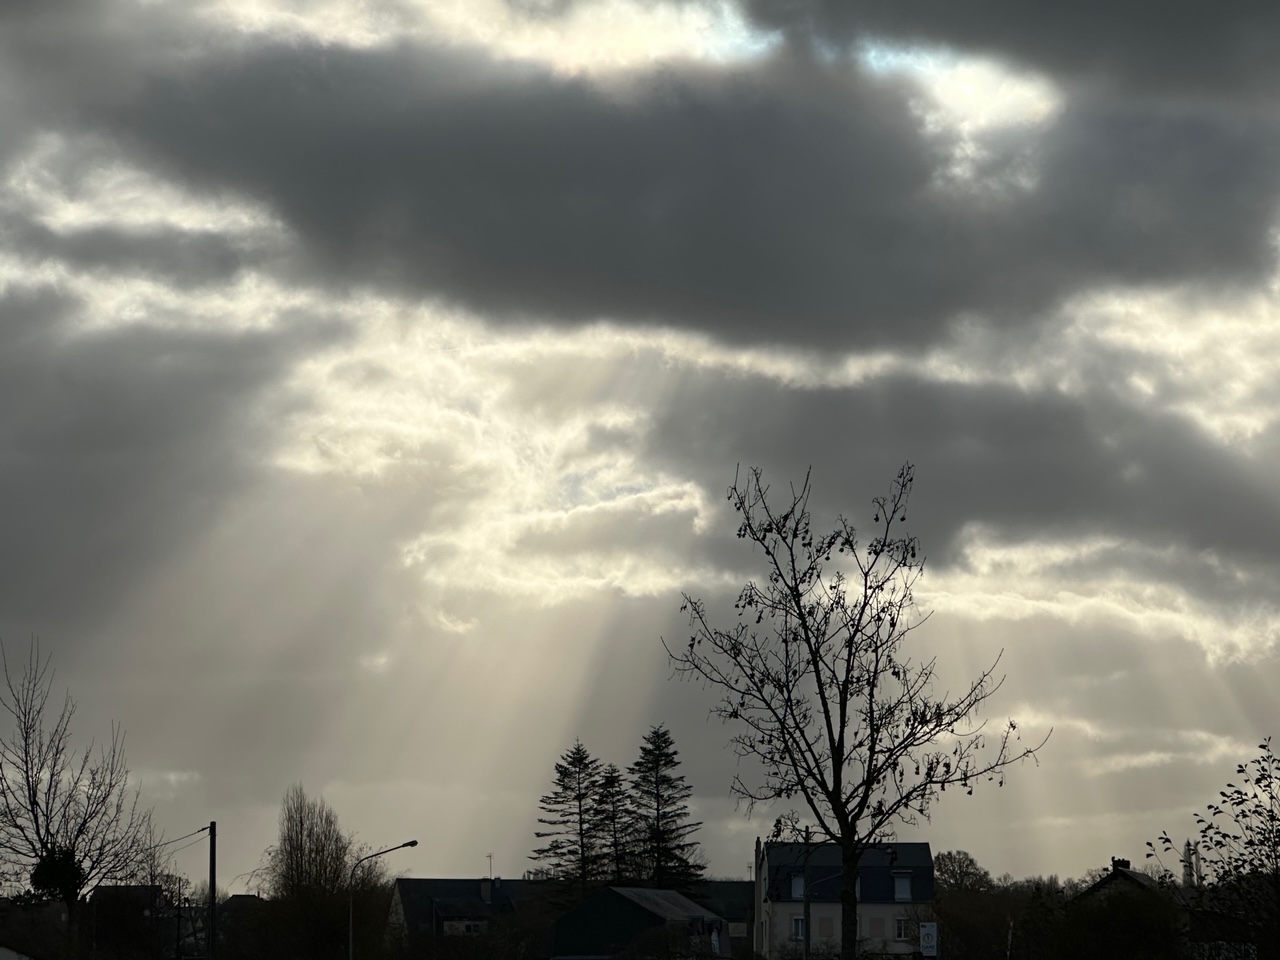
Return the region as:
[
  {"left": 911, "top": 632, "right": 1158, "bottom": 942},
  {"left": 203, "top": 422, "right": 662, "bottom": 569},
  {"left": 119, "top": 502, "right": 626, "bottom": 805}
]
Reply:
[{"left": 530, "top": 740, "right": 600, "bottom": 896}]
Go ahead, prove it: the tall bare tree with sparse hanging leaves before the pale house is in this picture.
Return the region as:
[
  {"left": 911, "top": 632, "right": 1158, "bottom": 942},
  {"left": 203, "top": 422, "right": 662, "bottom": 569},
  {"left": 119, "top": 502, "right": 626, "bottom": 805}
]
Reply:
[{"left": 663, "top": 465, "right": 1047, "bottom": 956}]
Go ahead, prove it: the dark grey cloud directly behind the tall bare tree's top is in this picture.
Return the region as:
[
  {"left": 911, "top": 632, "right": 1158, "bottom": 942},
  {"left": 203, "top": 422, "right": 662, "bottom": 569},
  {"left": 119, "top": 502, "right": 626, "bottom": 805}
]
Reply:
[{"left": 644, "top": 375, "right": 1280, "bottom": 607}]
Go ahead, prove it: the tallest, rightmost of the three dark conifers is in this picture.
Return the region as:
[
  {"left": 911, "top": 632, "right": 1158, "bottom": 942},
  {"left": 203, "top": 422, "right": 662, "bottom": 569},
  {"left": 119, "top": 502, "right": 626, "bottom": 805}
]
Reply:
[{"left": 627, "top": 724, "right": 704, "bottom": 888}]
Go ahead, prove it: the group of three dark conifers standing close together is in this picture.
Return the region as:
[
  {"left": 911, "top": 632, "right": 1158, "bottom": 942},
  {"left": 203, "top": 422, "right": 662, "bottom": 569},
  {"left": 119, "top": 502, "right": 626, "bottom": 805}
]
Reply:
[{"left": 530, "top": 724, "right": 705, "bottom": 896}]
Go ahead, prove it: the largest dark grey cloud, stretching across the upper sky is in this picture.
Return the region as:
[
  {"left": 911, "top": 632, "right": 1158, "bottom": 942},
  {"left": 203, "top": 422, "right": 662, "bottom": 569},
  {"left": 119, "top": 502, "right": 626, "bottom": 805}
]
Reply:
[{"left": 90, "top": 46, "right": 1280, "bottom": 344}]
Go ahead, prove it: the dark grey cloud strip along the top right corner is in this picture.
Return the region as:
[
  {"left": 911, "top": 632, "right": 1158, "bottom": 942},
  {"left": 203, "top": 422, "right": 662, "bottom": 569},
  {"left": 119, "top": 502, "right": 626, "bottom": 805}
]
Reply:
[{"left": 740, "top": 0, "right": 1280, "bottom": 96}]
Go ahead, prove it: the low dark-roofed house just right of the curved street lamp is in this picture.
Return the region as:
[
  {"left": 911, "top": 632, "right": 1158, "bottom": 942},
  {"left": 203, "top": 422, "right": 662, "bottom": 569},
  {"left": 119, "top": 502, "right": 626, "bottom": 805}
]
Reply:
[{"left": 387, "top": 877, "right": 532, "bottom": 956}]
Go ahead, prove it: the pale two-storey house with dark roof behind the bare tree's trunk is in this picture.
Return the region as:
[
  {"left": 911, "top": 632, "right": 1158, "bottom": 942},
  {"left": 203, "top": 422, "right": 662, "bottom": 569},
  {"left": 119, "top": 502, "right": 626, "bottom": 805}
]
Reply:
[{"left": 754, "top": 838, "right": 934, "bottom": 960}]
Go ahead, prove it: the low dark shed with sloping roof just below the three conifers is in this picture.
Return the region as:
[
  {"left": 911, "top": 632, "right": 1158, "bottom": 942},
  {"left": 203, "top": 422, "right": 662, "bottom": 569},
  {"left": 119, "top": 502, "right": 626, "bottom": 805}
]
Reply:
[{"left": 552, "top": 887, "right": 731, "bottom": 960}]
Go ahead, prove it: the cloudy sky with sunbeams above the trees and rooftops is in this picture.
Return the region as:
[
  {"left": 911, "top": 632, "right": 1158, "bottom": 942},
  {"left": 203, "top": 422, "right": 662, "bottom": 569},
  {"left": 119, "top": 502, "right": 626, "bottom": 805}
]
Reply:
[{"left": 0, "top": 0, "right": 1280, "bottom": 891}]
